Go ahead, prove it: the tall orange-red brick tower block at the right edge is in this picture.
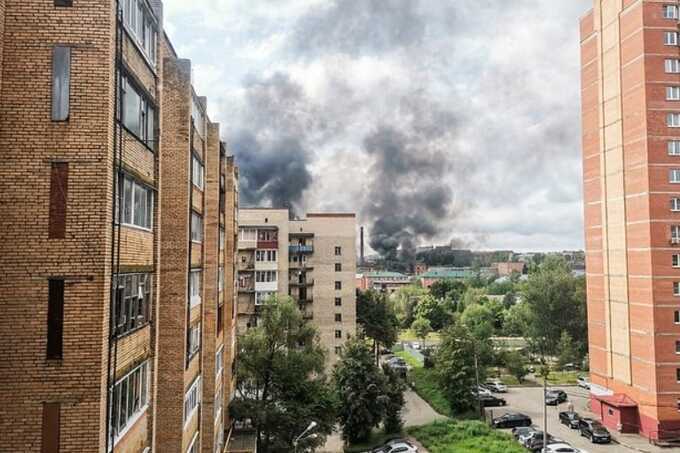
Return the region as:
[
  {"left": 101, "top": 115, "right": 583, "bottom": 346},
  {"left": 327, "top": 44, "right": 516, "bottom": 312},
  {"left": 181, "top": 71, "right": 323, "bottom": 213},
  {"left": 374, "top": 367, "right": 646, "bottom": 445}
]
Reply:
[{"left": 580, "top": 0, "right": 680, "bottom": 438}]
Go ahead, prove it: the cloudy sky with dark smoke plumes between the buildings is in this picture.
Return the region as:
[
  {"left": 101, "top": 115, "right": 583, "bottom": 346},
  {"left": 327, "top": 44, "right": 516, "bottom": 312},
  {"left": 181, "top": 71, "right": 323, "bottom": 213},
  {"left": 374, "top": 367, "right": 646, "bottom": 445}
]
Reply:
[{"left": 164, "top": 0, "right": 592, "bottom": 255}]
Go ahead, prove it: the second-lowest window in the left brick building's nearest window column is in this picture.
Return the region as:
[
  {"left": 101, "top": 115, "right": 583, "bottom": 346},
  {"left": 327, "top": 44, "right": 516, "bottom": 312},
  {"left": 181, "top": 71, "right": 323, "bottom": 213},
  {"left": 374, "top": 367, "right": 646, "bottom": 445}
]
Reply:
[{"left": 113, "top": 274, "right": 151, "bottom": 335}]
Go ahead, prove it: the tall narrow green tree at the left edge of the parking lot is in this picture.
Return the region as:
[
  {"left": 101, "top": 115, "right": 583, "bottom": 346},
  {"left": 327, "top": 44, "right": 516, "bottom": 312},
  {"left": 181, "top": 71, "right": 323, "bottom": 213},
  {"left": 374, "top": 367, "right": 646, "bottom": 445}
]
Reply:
[{"left": 434, "top": 322, "right": 483, "bottom": 413}]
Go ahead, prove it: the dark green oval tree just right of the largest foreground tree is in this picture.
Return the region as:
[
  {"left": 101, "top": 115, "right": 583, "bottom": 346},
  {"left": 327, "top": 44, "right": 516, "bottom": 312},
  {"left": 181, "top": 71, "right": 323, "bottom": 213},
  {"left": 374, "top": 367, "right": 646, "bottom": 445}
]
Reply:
[{"left": 333, "top": 339, "right": 388, "bottom": 443}]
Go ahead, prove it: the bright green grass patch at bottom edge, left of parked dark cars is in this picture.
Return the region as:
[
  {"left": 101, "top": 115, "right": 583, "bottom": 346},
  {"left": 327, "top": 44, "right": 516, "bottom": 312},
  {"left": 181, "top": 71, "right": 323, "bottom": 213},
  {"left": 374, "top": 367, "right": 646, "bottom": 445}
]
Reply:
[{"left": 408, "top": 420, "right": 526, "bottom": 453}]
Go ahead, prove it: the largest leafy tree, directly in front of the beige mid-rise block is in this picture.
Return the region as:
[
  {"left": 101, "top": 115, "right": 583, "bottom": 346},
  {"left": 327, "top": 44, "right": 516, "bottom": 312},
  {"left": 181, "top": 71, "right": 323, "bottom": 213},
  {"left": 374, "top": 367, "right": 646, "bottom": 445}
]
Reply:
[{"left": 230, "top": 297, "right": 336, "bottom": 452}]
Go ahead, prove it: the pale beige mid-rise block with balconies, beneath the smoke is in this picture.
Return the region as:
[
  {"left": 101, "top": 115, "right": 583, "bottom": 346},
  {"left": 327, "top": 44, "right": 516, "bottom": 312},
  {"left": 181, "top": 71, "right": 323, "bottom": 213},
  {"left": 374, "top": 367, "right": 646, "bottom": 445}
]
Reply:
[{"left": 237, "top": 209, "right": 357, "bottom": 364}]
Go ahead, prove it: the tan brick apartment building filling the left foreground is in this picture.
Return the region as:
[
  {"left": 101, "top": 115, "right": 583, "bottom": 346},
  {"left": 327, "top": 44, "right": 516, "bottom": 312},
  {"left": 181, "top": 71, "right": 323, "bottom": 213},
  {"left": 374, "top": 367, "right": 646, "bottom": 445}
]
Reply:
[{"left": 0, "top": 0, "right": 238, "bottom": 453}]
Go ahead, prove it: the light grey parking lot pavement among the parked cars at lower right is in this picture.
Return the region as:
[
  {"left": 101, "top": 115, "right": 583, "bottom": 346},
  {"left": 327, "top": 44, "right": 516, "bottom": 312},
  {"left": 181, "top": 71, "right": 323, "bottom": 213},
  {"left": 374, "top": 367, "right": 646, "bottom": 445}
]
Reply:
[{"left": 488, "top": 386, "right": 652, "bottom": 453}]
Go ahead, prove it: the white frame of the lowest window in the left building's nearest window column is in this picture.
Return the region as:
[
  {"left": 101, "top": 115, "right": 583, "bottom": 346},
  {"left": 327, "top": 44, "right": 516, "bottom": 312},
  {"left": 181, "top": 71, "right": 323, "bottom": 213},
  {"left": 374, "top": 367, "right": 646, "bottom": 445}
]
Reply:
[{"left": 109, "top": 360, "right": 150, "bottom": 449}]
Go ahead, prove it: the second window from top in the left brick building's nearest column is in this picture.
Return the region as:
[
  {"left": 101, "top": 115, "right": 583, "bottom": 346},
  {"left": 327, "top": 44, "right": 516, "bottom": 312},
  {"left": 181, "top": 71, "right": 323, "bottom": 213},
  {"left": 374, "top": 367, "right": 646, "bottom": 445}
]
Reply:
[{"left": 120, "top": 76, "right": 156, "bottom": 148}]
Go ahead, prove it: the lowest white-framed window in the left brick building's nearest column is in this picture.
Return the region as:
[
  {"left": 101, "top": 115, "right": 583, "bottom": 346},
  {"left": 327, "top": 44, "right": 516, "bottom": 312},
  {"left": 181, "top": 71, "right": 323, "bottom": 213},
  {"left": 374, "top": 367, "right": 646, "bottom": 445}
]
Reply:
[{"left": 110, "top": 361, "right": 149, "bottom": 442}]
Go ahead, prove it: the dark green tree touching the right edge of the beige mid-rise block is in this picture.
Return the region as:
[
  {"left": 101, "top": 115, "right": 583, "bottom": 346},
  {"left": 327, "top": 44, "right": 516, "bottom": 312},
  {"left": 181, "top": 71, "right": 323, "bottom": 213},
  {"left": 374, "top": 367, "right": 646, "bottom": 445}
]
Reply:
[{"left": 357, "top": 290, "right": 399, "bottom": 363}]
